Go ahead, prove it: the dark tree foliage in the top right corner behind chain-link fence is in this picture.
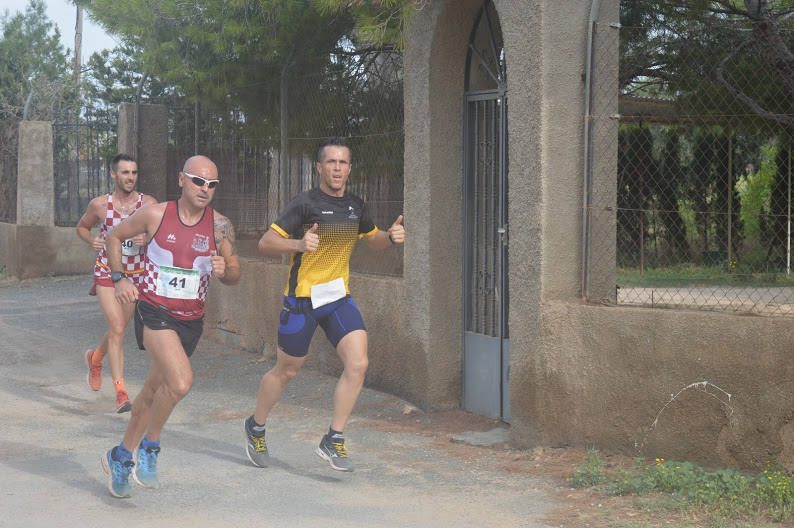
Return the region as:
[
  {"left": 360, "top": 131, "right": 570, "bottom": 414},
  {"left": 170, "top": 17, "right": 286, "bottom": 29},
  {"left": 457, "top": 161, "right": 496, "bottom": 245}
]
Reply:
[{"left": 620, "top": 0, "right": 792, "bottom": 126}]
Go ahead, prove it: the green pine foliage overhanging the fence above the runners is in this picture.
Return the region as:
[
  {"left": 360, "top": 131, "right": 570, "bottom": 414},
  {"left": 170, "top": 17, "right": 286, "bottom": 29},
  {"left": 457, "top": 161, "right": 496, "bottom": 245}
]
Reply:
[{"left": 86, "top": 0, "right": 353, "bottom": 121}]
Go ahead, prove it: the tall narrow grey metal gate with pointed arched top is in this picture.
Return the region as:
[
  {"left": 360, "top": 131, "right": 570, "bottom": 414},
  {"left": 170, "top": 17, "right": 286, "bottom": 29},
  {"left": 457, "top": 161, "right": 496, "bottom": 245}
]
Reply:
[{"left": 463, "top": 0, "right": 510, "bottom": 422}]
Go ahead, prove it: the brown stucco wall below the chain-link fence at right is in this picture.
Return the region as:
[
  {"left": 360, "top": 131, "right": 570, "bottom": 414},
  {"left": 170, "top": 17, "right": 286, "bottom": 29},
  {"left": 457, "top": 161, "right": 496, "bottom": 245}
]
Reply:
[{"left": 540, "top": 303, "right": 794, "bottom": 467}]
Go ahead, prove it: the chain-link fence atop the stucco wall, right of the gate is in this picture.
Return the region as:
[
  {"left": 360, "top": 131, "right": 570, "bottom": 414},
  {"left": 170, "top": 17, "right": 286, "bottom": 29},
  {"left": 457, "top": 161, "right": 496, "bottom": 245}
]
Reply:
[{"left": 584, "top": 1, "right": 794, "bottom": 314}]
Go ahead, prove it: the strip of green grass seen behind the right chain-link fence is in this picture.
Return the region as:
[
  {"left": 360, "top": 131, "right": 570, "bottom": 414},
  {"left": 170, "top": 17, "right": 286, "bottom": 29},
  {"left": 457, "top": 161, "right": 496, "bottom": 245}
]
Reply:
[{"left": 617, "top": 264, "right": 794, "bottom": 288}]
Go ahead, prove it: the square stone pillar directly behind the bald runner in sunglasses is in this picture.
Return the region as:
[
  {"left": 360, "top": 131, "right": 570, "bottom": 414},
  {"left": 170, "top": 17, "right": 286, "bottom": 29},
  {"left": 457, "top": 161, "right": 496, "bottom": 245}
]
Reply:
[{"left": 118, "top": 103, "right": 166, "bottom": 201}]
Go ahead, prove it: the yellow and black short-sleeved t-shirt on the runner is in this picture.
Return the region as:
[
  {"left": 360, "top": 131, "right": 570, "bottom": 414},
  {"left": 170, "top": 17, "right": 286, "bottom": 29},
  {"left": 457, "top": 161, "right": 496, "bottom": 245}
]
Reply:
[{"left": 270, "top": 187, "right": 378, "bottom": 297}]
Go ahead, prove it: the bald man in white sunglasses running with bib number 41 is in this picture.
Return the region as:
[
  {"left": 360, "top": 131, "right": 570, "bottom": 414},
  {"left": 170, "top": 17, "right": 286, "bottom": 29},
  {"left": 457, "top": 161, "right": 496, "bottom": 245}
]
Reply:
[{"left": 100, "top": 156, "right": 240, "bottom": 497}]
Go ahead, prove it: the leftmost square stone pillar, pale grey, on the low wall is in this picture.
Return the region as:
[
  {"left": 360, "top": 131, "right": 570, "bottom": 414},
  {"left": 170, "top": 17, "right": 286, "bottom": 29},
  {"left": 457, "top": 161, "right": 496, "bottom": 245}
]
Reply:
[{"left": 17, "top": 121, "right": 55, "bottom": 226}]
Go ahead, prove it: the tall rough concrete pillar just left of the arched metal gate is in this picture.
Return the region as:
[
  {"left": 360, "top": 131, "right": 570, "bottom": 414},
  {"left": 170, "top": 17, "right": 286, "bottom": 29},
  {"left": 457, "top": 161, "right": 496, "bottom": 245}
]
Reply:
[{"left": 403, "top": 0, "right": 482, "bottom": 408}]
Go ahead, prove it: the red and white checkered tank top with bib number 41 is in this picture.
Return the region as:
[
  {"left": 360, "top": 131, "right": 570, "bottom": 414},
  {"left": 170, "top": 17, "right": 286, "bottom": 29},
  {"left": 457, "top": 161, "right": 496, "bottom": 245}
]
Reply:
[{"left": 139, "top": 201, "right": 215, "bottom": 320}]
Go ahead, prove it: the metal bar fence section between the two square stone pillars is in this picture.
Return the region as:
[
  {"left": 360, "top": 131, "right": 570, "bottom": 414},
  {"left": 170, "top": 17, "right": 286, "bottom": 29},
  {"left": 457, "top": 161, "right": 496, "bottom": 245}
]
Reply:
[{"left": 52, "top": 112, "right": 118, "bottom": 227}]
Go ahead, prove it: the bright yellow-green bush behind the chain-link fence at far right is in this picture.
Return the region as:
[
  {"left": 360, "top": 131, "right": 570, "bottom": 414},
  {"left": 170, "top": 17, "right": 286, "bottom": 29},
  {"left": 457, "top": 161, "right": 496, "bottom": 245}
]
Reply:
[{"left": 736, "top": 145, "right": 780, "bottom": 240}]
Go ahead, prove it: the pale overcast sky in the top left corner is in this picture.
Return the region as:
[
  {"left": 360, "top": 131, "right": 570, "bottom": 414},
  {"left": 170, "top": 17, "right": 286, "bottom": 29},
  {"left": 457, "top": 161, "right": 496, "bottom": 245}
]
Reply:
[{"left": 0, "top": 0, "right": 116, "bottom": 62}]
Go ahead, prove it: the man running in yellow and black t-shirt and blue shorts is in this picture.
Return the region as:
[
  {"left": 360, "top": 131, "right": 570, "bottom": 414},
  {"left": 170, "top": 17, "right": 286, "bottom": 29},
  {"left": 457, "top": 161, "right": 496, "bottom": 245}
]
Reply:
[{"left": 244, "top": 139, "right": 405, "bottom": 471}]
